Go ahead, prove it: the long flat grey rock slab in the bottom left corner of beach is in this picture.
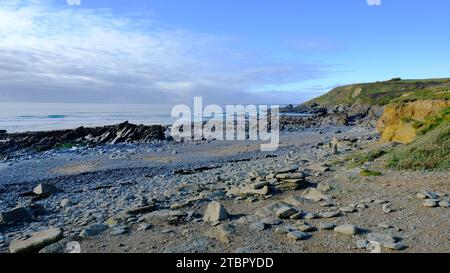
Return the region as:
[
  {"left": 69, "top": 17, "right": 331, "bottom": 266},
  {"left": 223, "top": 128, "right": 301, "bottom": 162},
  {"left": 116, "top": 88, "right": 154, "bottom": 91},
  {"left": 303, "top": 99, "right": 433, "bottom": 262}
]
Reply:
[{"left": 9, "top": 228, "right": 63, "bottom": 253}]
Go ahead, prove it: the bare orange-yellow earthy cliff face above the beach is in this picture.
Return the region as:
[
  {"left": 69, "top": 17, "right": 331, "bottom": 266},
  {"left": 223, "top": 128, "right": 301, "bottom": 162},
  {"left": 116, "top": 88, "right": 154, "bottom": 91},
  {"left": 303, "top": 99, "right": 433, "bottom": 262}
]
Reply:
[{"left": 377, "top": 99, "right": 450, "bottom": 143}]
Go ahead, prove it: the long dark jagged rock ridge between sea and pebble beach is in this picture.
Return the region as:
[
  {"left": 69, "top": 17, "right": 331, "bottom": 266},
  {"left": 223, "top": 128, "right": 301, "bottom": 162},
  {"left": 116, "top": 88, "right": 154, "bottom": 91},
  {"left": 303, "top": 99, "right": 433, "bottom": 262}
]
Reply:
[{"left": 0, "top": 122, "right": 165, "bottom": 158}]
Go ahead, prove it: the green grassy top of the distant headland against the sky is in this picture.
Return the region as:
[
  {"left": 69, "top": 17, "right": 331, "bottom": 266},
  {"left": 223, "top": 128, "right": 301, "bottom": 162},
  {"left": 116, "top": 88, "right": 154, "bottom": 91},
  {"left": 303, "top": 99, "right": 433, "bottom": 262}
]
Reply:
[{"left": 305, "top": 78, "right": 450, "bottom": 106}]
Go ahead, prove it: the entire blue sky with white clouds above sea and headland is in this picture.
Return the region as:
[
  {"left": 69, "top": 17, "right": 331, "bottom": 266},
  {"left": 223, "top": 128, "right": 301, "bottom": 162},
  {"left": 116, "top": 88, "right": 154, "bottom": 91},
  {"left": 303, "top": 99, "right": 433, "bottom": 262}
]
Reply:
[{"left": 0, "top": 0, "right": 450, "bottom": 104}]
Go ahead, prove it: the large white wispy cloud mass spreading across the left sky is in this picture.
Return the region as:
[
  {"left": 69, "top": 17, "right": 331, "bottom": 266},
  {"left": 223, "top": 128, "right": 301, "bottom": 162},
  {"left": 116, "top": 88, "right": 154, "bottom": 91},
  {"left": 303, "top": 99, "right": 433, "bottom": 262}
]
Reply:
[{"left": 0, "top": 0, "right": 330, "bottom": 103}]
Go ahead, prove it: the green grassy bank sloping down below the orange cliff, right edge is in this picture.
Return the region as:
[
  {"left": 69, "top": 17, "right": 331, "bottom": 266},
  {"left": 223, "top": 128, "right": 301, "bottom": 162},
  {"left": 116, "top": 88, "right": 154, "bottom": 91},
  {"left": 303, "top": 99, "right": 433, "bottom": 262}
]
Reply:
[{"left": 387, "top": 121, "right": 450, "bottom": 170}]
